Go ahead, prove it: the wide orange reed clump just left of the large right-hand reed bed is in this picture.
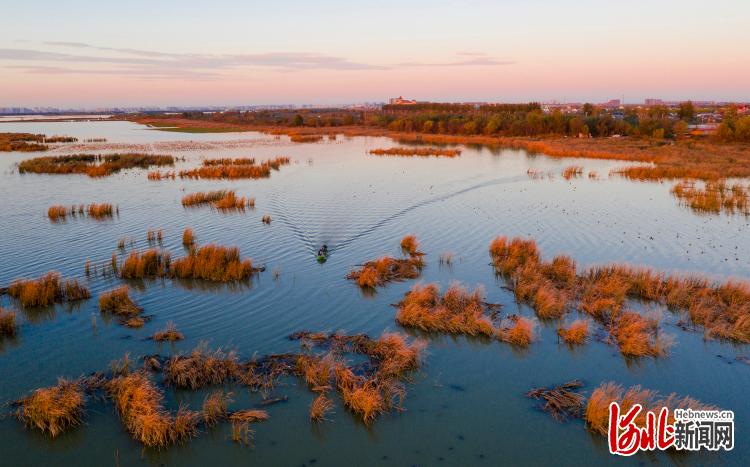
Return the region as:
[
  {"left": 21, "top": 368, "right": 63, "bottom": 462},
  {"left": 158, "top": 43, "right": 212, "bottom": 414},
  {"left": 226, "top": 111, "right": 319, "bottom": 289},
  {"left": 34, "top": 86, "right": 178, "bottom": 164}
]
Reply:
[{"left": 396, "top": 283, "right": 498, "bottom": 337}]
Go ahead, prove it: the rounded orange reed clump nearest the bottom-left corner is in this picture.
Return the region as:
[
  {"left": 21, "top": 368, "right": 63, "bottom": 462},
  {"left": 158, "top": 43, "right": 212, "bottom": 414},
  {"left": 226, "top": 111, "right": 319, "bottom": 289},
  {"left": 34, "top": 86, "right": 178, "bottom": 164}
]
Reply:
[{"left": 16, "top": 378, "right": 86, "bottom": 438}]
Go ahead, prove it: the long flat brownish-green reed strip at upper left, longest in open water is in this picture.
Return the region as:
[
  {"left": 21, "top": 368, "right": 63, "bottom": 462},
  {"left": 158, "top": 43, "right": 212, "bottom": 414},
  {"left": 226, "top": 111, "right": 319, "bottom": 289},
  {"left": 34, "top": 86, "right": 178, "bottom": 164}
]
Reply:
[{"left": 18, "top": 154, "right": 174, "bottom": 177}]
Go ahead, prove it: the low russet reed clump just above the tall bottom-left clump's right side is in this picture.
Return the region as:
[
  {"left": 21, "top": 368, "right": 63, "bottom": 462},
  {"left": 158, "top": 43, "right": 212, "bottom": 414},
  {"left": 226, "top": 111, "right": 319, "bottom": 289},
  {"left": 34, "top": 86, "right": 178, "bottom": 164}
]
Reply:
[{"left": 164, "top": 344, "right": 239, "bottom": 390}]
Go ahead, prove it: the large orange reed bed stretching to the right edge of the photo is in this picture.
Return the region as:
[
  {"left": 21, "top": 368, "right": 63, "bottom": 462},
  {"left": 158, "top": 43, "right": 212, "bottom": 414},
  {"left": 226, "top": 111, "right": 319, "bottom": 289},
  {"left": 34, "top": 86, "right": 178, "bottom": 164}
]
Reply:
[{"left": 490, "top": 237, "right": 750, "bottom": 350}]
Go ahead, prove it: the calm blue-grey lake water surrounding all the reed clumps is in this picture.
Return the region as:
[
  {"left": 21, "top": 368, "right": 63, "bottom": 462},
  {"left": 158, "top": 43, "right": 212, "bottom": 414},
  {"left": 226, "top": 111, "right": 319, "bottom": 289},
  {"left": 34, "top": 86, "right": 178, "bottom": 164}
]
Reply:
[{"left": 0, "top": 122, "right": 750, "bottom": 466}]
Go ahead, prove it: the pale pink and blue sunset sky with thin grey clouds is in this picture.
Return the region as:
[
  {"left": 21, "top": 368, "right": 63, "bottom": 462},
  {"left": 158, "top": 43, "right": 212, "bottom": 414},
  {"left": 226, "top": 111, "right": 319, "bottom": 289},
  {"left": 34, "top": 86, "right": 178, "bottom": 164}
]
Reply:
[{"left": 0, "top": 0, "right": 750, "bottom": 108}]
